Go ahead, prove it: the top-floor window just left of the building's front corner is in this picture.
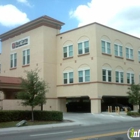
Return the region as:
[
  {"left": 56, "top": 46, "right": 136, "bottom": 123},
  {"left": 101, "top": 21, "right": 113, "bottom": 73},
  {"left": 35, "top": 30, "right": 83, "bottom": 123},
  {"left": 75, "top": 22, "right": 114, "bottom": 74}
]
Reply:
[{"left": 78, "top": 41, "right": 89, "bottom": 54}]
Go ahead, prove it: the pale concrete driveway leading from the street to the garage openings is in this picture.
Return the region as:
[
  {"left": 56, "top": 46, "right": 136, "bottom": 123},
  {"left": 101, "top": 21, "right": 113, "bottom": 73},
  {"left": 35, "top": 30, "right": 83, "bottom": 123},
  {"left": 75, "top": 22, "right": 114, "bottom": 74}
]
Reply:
[{"left": 64, "top": 112, "right": 140, "bottom": 126}]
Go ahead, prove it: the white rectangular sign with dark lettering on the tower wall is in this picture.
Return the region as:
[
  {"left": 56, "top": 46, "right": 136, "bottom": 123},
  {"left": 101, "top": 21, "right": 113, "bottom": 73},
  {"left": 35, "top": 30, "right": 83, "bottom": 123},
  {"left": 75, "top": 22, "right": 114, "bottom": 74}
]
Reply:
[{"left": 12, "top": 37, "right": 29, "bottom": 49}]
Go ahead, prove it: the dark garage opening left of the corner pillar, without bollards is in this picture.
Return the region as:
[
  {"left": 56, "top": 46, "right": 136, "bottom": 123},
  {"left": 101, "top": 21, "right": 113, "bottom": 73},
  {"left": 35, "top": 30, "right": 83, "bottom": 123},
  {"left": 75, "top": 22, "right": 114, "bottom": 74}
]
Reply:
[{"left": 66, "top": 96, "right": 91, "bottom": 113}]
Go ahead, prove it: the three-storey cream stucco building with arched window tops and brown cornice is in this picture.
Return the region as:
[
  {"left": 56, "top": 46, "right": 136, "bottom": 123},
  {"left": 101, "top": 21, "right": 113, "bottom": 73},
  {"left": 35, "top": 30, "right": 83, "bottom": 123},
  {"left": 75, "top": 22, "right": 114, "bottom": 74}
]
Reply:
[{"left": 0, "top": 16, "right": 140, "bottom": 113}]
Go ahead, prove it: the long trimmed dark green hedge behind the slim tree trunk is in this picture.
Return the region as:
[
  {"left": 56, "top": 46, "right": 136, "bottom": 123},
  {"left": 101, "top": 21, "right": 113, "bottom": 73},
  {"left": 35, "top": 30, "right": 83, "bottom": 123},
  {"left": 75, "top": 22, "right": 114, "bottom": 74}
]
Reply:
[{"left": 0, "top": 110, "right": 63, "bottom": 122}]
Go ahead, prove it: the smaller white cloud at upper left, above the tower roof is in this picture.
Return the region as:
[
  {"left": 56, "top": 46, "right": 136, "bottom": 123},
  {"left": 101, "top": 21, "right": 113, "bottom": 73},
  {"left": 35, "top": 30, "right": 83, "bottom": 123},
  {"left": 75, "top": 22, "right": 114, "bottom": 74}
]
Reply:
[{"left": 0, "top": 4, "right": 30, "bottom": 27}]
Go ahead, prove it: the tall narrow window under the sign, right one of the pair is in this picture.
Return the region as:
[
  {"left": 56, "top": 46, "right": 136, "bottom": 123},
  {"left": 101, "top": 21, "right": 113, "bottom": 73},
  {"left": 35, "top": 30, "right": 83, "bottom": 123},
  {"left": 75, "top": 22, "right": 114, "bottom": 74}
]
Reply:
[{"left": 23, "top": 49, "right": 30, "bottom": 65}]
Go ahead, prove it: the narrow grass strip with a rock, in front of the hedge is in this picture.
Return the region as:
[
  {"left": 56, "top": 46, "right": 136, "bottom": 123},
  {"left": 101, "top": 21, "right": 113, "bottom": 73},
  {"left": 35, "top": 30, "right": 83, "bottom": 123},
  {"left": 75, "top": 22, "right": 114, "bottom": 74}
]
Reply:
[{"left": 0, "top": 121, "right": 60, "bottom": 128}]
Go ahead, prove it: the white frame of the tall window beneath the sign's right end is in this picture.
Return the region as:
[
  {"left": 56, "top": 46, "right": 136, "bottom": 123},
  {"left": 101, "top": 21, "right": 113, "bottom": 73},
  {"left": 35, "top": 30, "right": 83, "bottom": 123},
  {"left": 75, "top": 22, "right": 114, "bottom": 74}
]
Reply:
[{"left": 22, "top": 48, "right": 30, "bottom": 66}]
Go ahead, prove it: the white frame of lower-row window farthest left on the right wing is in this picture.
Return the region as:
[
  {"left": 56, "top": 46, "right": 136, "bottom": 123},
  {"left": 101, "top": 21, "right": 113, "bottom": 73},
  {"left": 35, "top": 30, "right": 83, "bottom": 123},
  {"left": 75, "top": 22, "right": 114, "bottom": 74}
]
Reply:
[{"left": 63, "top": 71, "right": 74, "bottom": 84}]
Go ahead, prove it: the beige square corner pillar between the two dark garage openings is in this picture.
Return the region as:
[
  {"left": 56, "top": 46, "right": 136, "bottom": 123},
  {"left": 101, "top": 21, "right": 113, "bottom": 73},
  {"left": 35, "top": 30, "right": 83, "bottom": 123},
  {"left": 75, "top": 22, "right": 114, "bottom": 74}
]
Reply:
[{"left": 90, "top": 98, "right": 101, "bottom": 114}]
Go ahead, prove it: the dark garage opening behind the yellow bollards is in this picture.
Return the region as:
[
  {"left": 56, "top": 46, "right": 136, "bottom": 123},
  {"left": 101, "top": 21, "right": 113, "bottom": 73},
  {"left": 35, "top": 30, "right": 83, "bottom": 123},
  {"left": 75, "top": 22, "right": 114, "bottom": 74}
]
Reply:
[{"left": 101, "top": 96, "right": 133, "bottom": 112}]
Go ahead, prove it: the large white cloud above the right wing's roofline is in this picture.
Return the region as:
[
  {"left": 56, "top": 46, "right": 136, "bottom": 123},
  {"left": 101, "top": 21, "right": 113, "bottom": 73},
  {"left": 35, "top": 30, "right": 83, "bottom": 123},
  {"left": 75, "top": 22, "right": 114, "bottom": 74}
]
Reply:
[{"left": 69, "top": 0, "right": 140, "bottom": 37}]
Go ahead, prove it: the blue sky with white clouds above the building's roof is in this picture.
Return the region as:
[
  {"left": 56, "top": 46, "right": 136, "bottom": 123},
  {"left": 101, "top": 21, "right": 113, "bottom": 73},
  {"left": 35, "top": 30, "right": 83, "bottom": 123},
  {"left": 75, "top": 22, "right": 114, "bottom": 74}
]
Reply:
[{"left": 0, "top": 0, "right": 140, "bottom": 52}]
